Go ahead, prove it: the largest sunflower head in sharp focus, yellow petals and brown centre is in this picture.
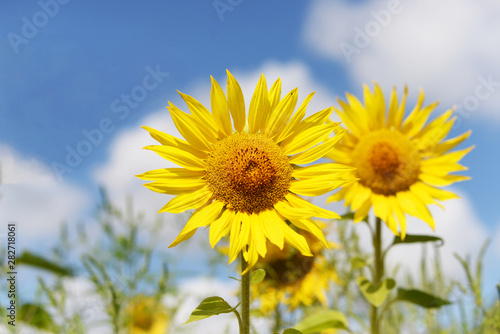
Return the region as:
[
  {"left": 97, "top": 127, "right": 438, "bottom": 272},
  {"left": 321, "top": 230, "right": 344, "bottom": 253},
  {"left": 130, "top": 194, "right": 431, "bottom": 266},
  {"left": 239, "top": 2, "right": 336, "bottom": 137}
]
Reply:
[{"left": 137, "top": 71, "right": 352, "bottom": 268}]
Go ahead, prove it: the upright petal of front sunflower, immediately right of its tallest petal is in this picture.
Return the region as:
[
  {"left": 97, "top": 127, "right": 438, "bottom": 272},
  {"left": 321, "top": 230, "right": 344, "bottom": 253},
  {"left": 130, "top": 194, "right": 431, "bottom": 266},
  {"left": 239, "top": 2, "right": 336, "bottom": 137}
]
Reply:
[{"left": 248, "top": 74, "right": 269, "bottom": 133}]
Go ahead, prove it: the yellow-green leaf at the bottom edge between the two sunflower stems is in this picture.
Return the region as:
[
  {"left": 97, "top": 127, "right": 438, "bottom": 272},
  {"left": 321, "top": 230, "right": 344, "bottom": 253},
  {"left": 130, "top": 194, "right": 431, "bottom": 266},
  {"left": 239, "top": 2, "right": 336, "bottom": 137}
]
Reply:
[{"left": 296, "top": 310, "right": 348, "bottom": 334}]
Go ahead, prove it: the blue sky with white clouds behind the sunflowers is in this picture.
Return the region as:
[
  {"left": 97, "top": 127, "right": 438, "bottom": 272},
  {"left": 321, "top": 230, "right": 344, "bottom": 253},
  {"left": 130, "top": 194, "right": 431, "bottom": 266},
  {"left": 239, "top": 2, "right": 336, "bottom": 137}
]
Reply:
[{"left": 0, "top": 0, "right": 500, "bottom": 332}]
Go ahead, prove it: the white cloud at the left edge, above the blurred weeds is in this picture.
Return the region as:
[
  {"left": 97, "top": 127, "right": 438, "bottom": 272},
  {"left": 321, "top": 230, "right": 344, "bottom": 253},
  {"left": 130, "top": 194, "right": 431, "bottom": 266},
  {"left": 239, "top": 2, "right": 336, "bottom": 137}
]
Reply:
[{"left": 0, "top": 144, "right": 90, "bottom": 245}]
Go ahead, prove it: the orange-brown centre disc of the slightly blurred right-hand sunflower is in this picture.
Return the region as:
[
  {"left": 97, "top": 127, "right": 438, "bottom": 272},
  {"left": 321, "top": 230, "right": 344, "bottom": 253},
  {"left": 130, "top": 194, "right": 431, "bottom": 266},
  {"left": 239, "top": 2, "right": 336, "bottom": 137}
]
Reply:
[{"left": 352, "top": 129, "right": 420, "bottom": 196}]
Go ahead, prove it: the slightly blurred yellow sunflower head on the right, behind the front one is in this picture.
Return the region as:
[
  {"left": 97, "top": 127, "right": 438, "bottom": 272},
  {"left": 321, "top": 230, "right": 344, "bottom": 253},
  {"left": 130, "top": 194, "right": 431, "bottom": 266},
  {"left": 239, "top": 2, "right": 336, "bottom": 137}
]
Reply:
[{"left": 328, "top": 84, "right": 473, "bottom": 239}]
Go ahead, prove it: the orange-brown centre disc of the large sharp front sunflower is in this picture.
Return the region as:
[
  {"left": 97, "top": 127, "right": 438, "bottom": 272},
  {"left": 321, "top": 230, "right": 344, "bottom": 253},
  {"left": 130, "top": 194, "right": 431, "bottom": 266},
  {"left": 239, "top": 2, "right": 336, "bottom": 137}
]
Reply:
[{"left": 205, "top": 133, "right": 292, "bottom": 214}]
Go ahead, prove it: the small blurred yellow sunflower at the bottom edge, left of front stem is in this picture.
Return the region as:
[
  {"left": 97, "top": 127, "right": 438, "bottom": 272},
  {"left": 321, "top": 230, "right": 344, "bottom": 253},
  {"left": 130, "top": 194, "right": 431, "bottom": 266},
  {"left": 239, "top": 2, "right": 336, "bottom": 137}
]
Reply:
[{"left": 125, "top": 295, "right": 169, "bottom": 334}]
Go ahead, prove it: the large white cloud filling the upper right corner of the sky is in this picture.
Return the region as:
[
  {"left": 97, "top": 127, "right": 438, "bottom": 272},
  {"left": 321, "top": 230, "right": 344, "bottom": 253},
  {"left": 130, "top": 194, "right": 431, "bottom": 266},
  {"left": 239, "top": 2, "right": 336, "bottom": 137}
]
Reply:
[{"left": 304, "top": 0, "right": 500, "bottom": 121}]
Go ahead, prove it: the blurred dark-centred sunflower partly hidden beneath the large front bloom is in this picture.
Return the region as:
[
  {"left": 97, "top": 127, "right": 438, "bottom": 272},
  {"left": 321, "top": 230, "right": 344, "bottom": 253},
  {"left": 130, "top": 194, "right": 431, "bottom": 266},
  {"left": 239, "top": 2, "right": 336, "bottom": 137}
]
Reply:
[{"left": 252, "top": 231, "right": 341, "bottom": 314}]
